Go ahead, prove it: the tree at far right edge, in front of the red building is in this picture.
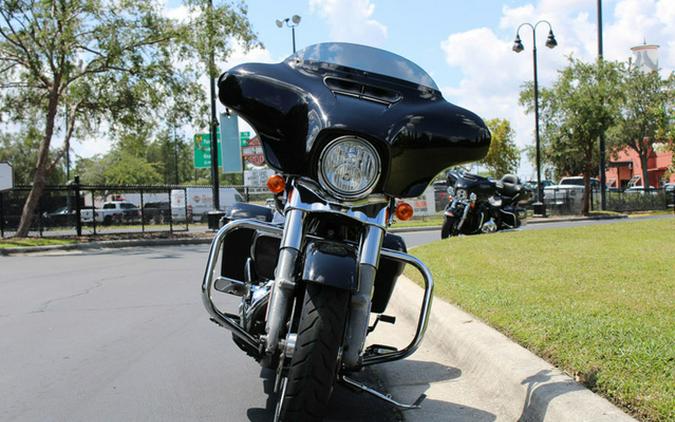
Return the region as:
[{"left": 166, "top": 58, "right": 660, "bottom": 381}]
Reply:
[{"left": 608, "top": 66, "right": 675, "bottom": 188}]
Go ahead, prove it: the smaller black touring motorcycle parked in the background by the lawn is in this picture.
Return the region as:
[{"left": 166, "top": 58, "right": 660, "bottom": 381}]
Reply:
[{"left": 441, "top": 171, "right": 531, "bottom": 239}]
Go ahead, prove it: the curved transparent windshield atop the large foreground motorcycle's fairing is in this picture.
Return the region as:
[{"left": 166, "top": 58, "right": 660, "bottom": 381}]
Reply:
[{"left": 289, "top": 43, "right": 438, "bottom": 90}]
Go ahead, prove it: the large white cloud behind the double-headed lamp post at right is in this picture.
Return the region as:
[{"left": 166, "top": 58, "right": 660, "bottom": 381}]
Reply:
[{"left": 440, "top": 0, "right": 675, "bottom": 177}]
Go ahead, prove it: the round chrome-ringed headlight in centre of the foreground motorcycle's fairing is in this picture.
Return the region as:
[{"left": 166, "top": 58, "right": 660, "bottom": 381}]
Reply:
[{"left": 318, "top": 136, "right": 381, "bottom": 199}]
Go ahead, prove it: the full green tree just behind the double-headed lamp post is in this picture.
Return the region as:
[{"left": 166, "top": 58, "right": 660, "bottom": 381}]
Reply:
[{"left": 520, "top": 57, "right": 619, "bottom": 214}]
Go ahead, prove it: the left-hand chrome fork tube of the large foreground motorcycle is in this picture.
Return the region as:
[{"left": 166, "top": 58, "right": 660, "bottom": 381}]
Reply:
[{"left": 265, "top": 209, "right": 305, "bottom": 355}]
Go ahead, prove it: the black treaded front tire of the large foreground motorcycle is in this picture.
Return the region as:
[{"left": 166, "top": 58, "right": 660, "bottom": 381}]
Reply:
[{"left": 275, "top": 283, "right": 350, "bottom": 422}]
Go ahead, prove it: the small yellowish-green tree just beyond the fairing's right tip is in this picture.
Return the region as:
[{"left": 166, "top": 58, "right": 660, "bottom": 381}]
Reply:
[{"left": 481, "top": 119, "right": 520, "bottom": 177}]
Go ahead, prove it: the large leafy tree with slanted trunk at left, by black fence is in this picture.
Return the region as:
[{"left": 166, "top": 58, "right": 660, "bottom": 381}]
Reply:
[{"left": 0, "top": 0, "right": 255, "bottom": 237}]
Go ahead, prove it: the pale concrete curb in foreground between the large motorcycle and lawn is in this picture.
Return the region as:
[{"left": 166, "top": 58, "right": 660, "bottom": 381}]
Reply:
[{"left": 375, "top": 277, "right": 634, "bottom": 421}]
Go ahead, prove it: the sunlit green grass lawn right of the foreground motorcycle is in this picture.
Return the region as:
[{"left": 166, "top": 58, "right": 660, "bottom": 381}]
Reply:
[{"left": 409, "top": 219, "right": 675, "bottom": 420}]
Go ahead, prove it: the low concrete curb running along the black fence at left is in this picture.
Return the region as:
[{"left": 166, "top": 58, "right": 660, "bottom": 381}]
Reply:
[{"left": 0, "top": 237, "right": 211, "bottom": 255}]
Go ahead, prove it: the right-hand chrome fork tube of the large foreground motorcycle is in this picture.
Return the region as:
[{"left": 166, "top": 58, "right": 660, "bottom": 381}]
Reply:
[{"left": 342, "top": 226, "right": 384, "bottom": 368}]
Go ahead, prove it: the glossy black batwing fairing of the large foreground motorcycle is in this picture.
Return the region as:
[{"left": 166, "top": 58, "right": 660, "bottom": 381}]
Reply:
[{"left": 218, "top": 51, "right": 490, "bottom": 197}]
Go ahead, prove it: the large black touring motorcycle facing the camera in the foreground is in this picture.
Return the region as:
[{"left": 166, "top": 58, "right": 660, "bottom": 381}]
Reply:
[{"left": 202, "top": 43, "right": 490, "bottom": 421}]
